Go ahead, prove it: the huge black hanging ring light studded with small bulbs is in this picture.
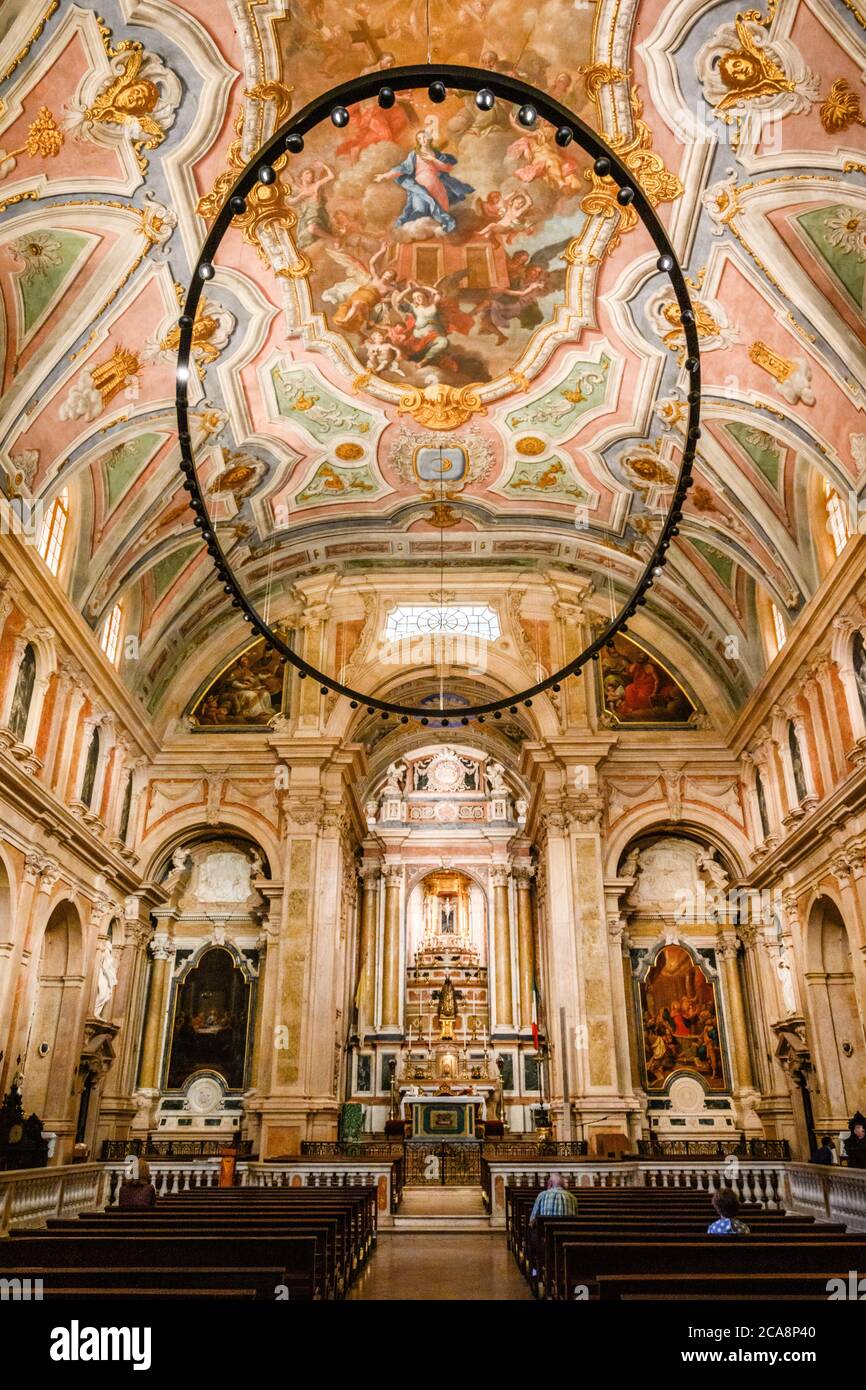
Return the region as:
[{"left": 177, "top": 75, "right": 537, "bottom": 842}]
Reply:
[{"left": 175, "top": 64, "right": 701, "bottom": 724}]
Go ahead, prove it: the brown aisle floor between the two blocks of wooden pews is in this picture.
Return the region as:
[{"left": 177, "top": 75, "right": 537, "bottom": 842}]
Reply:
[{"left": 349, "top": 1232, "right": 532, "bottom": 1301}]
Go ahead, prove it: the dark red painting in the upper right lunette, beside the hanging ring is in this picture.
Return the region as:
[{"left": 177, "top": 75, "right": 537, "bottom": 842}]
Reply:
[{"left": 596, "top": 632, "right": 695, "bottom": 728}]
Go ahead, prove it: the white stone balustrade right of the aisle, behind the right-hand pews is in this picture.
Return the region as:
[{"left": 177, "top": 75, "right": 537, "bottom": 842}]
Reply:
[{"left": 481, "top": 1154, "right": 787, "bottom": 1226}]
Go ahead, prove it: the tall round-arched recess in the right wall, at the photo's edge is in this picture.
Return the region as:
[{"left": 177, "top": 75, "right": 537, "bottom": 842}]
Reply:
[{"left": 805, "top": 891, "right": 866, "bottom": 1129}]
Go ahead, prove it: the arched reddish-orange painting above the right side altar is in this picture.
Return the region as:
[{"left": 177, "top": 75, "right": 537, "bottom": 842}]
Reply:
[{"left": 632, "top": 942, "right": 728, "bottom": 1095}]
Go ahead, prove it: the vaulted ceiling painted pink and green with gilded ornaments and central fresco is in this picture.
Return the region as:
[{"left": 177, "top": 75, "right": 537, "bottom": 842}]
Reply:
[{"left": 0, "top": 0, "right": 866, "bottom": 721}]
